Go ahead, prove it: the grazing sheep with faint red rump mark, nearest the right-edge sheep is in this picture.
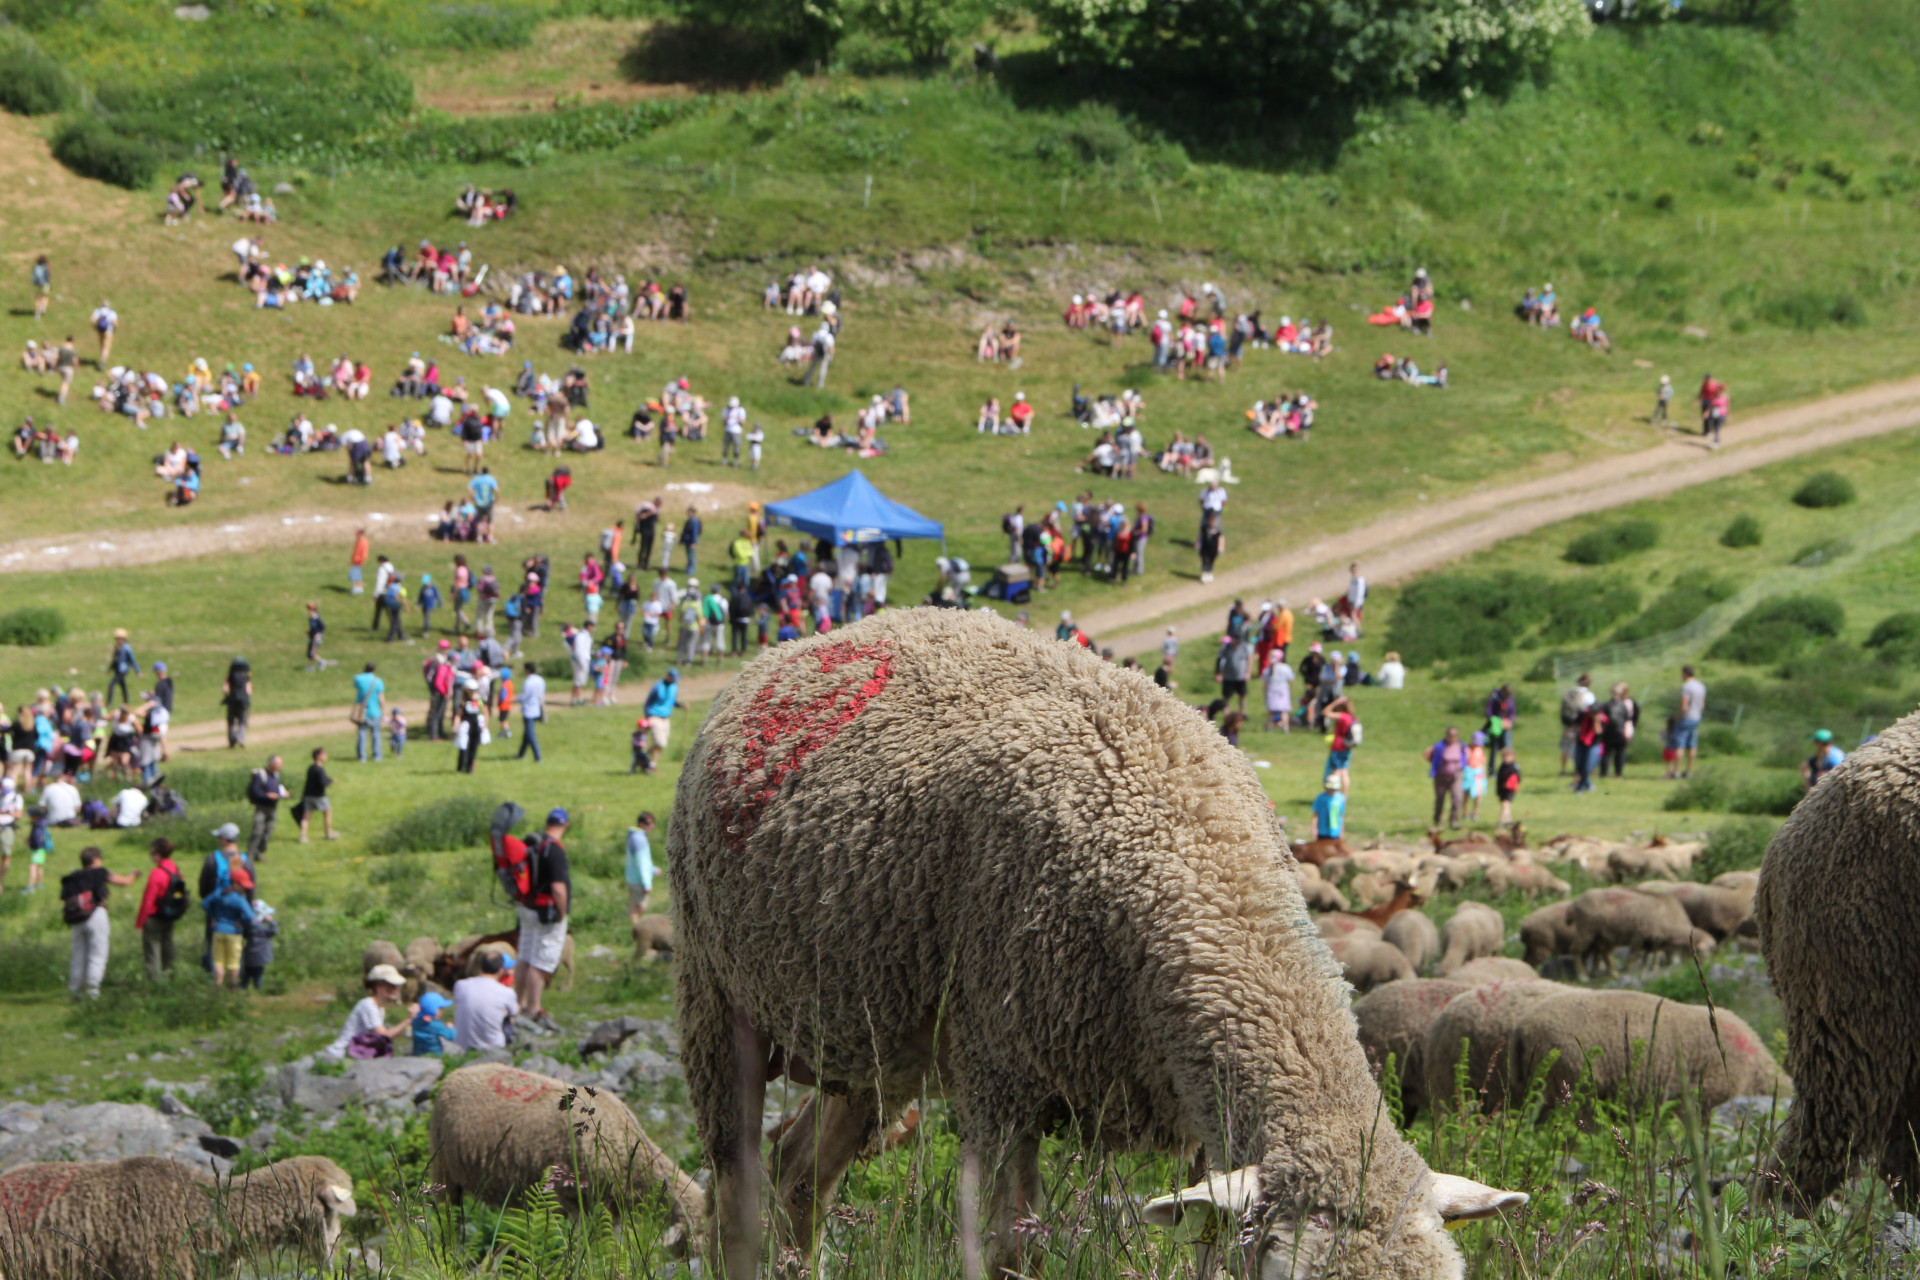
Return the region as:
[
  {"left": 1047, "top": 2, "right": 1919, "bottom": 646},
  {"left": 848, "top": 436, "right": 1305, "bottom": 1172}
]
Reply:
[{"left": 1509, "top": 988, "right": 1789, "bottom": 1111}]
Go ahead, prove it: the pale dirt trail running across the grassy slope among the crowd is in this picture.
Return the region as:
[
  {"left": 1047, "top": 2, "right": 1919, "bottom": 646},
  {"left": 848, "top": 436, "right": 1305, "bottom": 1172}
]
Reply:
[{"left": 157, "top": 378, "right": 1920, "bottom": 750}]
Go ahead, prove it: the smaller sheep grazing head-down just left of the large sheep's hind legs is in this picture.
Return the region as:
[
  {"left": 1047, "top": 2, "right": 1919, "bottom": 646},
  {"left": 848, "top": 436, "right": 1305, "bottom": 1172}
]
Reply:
[{"left": 426, "top": 1063, "right": 705, "bottom": 1234}]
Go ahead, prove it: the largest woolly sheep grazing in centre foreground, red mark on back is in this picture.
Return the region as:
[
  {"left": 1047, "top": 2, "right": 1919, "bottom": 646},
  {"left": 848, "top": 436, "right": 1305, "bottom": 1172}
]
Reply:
[{"left": 668, "top": 608, "right": 1524, "bottom": 1280}]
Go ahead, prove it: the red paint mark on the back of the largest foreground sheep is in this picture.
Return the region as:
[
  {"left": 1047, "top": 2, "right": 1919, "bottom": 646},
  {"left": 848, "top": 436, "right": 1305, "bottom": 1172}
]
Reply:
[{"left": 708, "top": 641, "right": 893, "bottom": 848}]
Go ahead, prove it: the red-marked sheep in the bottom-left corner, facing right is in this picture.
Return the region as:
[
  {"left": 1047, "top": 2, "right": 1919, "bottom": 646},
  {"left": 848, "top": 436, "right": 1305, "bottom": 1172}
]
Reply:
[{"left": 0, "top": 1155, "right": 355, "bottom": 1280}]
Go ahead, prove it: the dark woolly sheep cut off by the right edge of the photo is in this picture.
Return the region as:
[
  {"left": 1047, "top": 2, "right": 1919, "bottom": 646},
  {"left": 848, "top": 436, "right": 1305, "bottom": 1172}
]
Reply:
[{"left": 1755, "top": 716, "right": 1920, "bottom": 1211}]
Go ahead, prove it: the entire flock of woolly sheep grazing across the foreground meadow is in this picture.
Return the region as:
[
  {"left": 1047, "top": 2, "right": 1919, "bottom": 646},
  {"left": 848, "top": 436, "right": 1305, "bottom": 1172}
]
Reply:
[{"left": 0, "top": 610, "right": 1920, "bottom": 1280}]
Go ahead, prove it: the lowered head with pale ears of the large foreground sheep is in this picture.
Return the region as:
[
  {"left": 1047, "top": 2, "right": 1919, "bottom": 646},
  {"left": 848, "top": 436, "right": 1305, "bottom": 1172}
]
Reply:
[{"left": 1144, "top": 1165, "right": 1526, "bottom": 1280}]
